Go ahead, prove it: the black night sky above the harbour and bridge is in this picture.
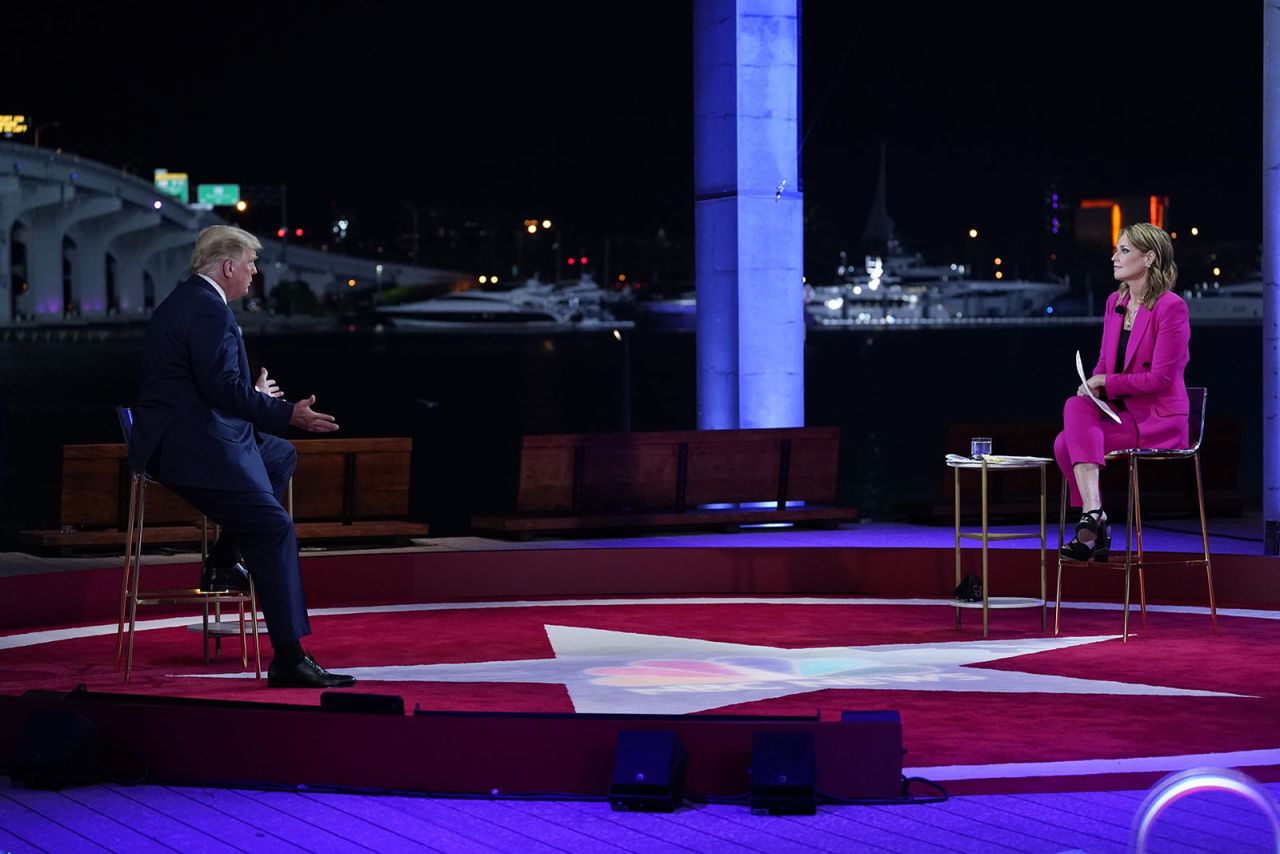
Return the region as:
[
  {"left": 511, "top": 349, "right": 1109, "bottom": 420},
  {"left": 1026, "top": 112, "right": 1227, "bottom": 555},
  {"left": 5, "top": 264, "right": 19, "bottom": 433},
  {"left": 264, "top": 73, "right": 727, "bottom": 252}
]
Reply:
[{"left": 10, "top": 0, "right": 1262, "bottom": 280}]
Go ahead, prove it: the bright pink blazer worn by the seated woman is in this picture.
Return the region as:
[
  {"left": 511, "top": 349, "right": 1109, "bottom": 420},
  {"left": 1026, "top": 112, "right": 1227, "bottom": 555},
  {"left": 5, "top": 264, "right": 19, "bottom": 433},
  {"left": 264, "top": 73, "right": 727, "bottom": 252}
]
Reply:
[{"left": 1093, "top": 291, "right": 1192, "bottom": 448}]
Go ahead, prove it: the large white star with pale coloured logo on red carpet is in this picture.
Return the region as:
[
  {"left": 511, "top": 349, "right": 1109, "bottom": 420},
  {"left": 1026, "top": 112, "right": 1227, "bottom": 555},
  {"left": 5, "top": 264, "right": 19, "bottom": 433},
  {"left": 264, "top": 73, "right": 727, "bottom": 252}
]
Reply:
[{"left": 180, "top": 626, "right": 1242, "bottom": 714}]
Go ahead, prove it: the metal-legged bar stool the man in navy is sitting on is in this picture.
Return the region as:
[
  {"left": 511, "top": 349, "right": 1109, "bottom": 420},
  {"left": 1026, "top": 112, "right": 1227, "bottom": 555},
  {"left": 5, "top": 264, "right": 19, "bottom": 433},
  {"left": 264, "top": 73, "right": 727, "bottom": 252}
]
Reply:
[{"left": 115, "top": 406, "right": 262, "bottom": 682}]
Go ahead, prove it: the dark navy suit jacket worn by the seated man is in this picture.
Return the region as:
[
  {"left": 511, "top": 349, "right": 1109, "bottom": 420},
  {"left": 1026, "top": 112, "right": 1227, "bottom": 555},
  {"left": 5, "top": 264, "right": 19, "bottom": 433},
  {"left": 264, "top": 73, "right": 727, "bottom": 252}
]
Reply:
[{"left": 129, "top": 275, "right": 293, "bottom": 492}]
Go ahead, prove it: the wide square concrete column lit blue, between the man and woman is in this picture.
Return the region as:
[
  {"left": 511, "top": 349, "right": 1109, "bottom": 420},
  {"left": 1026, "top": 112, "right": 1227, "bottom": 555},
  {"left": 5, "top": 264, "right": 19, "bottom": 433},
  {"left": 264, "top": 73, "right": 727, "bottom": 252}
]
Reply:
[{"left": 694, "top": 0, "right": 804, "bottom": 429}]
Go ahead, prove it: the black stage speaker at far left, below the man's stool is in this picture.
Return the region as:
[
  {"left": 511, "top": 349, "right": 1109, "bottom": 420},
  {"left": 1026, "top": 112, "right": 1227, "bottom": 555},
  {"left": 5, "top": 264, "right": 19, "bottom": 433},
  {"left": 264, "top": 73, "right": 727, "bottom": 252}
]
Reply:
[{"left": 9, "top": 709, "right": 105, "bottom": 791}]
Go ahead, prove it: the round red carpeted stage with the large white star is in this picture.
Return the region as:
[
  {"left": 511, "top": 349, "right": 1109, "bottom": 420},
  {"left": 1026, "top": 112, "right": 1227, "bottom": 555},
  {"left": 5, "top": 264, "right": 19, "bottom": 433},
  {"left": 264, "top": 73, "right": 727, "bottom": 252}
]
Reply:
[{"left": 0, "top": 530, "right": 1280, "bottom": 793}]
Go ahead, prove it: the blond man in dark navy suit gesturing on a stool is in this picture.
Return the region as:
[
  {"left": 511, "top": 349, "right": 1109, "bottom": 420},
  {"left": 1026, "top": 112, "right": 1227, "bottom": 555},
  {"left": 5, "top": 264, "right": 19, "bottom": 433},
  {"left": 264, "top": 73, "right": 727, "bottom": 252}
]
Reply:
[{"left": 129, "top": 225, "right": 356, "bottom": 688}]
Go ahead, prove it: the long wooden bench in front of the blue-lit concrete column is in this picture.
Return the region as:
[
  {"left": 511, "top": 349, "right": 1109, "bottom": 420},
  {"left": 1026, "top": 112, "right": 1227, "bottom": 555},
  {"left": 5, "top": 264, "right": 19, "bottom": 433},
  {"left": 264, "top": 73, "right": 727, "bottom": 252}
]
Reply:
[{"left": 471, "top": 428, "right": 858, "bottom": 536}]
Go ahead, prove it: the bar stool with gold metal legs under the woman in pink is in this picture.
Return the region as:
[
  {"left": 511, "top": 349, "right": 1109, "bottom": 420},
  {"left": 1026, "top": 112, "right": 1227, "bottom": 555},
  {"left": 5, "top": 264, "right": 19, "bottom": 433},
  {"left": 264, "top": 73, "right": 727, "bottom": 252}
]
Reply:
[{"left": 1053, "top": 387, "right": 1217, "bottom": 641}]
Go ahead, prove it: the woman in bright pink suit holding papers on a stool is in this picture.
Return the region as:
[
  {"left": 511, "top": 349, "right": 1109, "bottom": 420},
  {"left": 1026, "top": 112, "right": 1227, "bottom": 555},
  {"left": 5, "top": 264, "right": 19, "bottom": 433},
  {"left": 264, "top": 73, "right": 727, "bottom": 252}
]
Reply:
[{"left": 1053, "top": 223, "right": 1192, "bottom": 561}]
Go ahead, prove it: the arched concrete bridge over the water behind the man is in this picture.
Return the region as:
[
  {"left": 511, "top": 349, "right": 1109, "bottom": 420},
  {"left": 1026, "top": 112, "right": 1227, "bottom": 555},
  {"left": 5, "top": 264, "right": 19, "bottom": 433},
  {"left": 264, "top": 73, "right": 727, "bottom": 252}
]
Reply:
[{"left": 0, "top": 142, "right": 471, "bottom": 324}]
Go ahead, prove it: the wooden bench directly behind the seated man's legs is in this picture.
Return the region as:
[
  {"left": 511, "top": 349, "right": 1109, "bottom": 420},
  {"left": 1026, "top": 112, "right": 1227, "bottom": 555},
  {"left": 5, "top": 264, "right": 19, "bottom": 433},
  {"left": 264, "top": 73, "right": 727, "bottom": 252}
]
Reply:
[{"left": 20, "top": 438, "right": 428, "bottom": 551}]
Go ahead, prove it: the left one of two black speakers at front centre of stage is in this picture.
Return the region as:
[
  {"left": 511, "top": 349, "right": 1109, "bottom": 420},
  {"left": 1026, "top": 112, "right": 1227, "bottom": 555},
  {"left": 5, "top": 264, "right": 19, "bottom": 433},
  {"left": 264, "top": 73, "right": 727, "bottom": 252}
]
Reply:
[{"left": 609, "top": 730, "right": 689, "bottom": 813}]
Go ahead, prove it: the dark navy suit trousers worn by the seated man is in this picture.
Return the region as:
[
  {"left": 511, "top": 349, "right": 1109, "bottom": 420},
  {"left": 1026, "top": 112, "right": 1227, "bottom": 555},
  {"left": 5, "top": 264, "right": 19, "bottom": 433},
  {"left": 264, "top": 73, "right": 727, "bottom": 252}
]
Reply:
[{"left": 166, "top": 435, "right": 311, "bottom": 647}]
